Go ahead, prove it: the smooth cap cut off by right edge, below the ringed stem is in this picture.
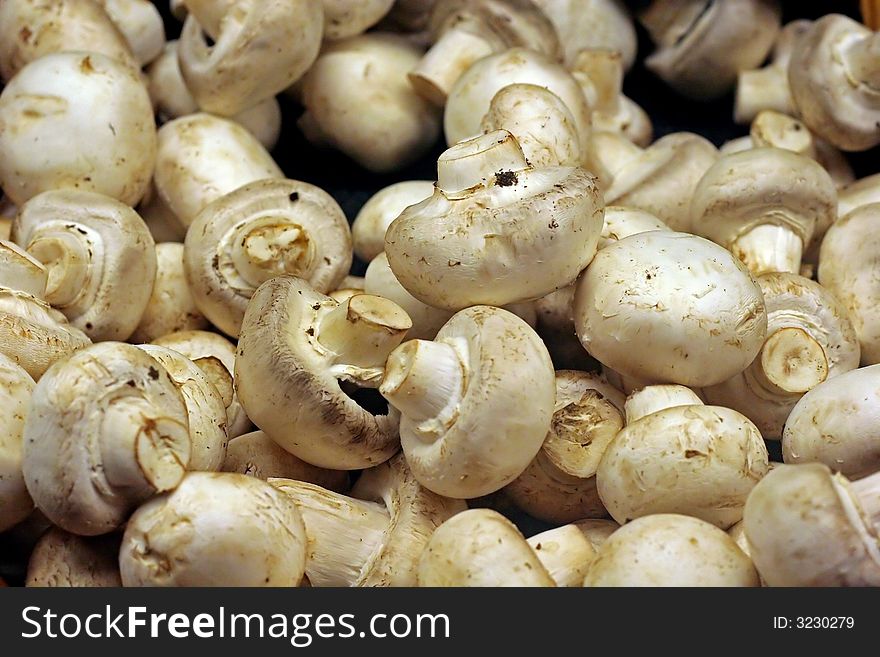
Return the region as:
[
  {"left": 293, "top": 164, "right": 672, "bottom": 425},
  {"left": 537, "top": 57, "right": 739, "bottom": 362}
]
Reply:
[{"left": 782, "top": 365, "right": 880, "bottom": 479}]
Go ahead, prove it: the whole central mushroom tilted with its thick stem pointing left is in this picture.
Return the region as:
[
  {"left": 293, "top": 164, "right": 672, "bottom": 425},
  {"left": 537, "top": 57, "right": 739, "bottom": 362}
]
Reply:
[{"left": 379, "top": 306, "right": 555, "bottom": 499}]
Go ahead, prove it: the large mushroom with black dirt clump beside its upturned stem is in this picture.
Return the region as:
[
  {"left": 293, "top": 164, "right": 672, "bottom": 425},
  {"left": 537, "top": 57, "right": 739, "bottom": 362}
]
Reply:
[{"left": 385, "top": 130, "right": 603, "bottom": 310}]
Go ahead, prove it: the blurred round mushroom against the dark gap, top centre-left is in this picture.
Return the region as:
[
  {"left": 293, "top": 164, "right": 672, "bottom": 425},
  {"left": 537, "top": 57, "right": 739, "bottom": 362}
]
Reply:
[{"left": 299, "top": 32, "right": 440, "bottom": 173}]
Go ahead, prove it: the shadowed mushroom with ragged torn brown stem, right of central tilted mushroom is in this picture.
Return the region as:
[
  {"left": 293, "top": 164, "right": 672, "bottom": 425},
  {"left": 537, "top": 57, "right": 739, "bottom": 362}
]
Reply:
[{"left": 504, "top": 370, "right": 624, "bottom": 524}]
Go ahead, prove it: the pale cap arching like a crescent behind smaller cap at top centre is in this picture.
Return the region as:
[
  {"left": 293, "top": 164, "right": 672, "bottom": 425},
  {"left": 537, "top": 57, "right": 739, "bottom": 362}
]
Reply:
[{"left": 443, "top": 48, "right": 591, "bottom": 154}]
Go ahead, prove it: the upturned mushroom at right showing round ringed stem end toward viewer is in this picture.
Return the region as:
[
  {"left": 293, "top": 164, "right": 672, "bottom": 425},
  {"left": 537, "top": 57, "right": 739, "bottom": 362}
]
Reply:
[{"left": 703, "top": 273, "right": 859, "bottom": 440}]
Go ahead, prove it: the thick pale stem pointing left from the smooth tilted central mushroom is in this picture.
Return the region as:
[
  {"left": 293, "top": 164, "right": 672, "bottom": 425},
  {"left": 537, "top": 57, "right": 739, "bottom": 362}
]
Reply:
[{"left": 379, "top": 340, "right": 465, "bottom": 427}]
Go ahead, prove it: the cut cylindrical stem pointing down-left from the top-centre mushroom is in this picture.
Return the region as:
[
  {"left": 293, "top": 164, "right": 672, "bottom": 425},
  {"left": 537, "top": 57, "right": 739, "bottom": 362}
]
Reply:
[{"left": 408, "top": 29, "right": 494, "bottom": 107}]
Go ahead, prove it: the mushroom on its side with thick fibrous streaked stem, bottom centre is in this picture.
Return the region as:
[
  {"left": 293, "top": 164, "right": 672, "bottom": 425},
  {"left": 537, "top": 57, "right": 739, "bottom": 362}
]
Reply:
[{"left": 269, "top": 455, "right": 467, "bottom": 586}]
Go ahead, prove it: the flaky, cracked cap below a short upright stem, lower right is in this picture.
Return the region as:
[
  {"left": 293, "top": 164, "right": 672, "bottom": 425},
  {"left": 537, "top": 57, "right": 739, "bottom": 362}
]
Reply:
[{"left": 596, "top": 406, "right": 769, "bottom": 529}]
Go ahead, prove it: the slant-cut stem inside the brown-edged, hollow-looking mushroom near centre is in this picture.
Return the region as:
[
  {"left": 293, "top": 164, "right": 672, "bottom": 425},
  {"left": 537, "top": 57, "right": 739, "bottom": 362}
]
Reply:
[{"left": 317, "top": 294, "right": 412, "bottom": 367}]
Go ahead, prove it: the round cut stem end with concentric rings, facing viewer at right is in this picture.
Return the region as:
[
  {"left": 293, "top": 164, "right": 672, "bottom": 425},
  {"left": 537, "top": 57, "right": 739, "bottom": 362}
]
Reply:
[{"left": 748, "top": 326, "right": 828, "bottom": 394}]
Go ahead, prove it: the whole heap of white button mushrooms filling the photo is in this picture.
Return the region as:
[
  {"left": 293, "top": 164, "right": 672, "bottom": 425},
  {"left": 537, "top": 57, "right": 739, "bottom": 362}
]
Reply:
[{"left": 0, "top": 0, "right": 880, "bottom": 587}]
